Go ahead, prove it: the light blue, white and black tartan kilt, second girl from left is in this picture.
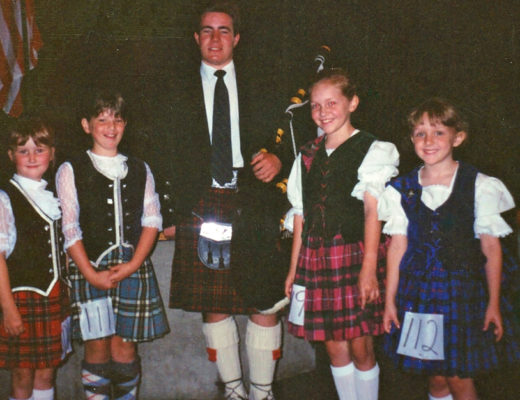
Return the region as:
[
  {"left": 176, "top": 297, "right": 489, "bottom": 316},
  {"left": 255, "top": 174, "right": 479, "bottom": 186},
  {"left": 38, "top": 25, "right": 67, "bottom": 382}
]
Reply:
[{"left": 69, "top": 250, "right": 170, "bottom": 342}]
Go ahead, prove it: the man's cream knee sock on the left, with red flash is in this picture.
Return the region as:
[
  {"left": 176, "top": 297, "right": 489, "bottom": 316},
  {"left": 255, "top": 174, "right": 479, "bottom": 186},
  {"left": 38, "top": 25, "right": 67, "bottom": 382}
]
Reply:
[{"left": 202, "top": 317, "right": 247, "bottom": 399}]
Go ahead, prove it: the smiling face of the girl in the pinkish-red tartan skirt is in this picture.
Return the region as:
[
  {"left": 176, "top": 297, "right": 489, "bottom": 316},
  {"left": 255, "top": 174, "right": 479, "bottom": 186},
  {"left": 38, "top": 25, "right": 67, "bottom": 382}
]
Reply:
[{"left": 311, "top": 80, "right": 359, "bottom": 137}]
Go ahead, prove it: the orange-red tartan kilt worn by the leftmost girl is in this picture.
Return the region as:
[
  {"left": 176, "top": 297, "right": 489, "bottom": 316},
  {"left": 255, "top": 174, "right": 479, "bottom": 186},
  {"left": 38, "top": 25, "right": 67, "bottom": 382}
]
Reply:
[{"left": 0, "top": 281, "right": 69, "bottom": 369}]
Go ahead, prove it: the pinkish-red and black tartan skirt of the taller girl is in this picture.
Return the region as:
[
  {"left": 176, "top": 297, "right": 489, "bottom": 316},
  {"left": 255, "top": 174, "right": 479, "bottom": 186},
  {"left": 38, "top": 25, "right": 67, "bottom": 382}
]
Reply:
[{"left": 288, "top": 234, "right": 387, "bottom": 341}]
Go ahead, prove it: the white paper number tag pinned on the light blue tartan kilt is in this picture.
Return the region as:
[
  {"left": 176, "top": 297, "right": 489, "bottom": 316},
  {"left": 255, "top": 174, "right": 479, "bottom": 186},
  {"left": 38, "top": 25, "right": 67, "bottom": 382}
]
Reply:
[{"left": 79, "top": 297, "right": 116, "bottom": 340}]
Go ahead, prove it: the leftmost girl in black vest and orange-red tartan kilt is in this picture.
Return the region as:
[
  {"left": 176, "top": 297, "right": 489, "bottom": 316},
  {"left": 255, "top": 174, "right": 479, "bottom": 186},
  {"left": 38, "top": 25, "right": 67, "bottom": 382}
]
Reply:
[{"left": 0, "top": 119, "right": 70, "bottom": 400}]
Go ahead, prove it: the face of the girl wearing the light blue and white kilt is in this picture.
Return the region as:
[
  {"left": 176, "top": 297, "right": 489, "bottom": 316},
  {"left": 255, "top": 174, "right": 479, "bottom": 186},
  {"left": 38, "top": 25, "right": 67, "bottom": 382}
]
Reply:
[{"left": 81, "top": 110, "right": 126, "bottom": 157}]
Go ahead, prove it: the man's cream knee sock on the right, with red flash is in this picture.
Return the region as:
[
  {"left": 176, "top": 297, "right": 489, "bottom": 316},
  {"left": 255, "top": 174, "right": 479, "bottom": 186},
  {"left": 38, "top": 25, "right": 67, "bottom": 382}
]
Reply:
[{"left": 246, "top": 320, "right": 282, "bottom": 400}]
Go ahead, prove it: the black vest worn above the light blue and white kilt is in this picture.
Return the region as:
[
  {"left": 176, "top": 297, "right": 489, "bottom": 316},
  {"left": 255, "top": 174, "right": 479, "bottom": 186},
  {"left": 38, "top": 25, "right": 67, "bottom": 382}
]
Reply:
[{"left": 70, "top": 153, "right": 146, "bottom": 262}]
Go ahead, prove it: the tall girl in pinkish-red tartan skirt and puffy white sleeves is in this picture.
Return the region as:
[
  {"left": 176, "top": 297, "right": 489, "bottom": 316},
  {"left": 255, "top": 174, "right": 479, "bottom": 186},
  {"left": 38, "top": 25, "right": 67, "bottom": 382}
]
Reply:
[{"left": 285, "top": 69, "right": 399, "bottom": 400}]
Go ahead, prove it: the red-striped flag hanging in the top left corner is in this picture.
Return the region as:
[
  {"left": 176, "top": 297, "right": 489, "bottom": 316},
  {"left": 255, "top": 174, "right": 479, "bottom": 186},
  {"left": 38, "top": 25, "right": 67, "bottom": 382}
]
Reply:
[{"left": 0, "top": 0, "right": 43, "bottom": 117}]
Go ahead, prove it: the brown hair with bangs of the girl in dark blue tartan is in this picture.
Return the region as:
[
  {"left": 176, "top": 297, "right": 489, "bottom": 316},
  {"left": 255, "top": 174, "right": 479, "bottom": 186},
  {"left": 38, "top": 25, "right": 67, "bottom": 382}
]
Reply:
[{"left": 408, "top": 97, "right": 469, "bottom": 133}]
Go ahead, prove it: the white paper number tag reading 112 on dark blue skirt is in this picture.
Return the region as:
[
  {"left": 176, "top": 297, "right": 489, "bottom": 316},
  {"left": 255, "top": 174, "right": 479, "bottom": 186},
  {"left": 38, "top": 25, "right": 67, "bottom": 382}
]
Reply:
[{"left": 397, "top": 311, "right": 444, "bottom": 360}]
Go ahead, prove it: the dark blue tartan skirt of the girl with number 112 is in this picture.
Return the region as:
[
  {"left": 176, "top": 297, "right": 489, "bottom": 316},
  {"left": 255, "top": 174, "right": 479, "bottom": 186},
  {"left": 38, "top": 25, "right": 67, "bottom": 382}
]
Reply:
[{"left": 384, "top": 256, "right": 520, "bottom": 378}]
